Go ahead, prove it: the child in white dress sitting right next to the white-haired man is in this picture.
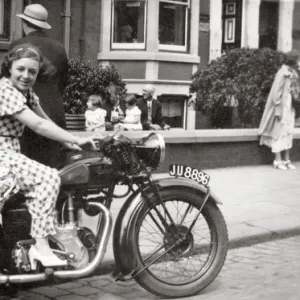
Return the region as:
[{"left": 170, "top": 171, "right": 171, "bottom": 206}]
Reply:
[{"left": 115, "top": 95, "right": 143, "bottom": 130}]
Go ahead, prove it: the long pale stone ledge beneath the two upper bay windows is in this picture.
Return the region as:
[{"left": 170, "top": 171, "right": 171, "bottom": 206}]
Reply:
[{"left": 97, "top": 50, "right": 200, "bottom": 64}]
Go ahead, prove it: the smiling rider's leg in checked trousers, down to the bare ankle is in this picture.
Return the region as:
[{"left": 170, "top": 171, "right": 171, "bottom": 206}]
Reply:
[{"left": 1, "top": 151, "right": 60, "bottom": 256}]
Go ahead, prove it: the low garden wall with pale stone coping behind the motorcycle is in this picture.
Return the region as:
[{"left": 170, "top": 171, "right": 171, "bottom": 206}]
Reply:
[{"left": 74, "top": 128, "right": 300, "bottom": 173}]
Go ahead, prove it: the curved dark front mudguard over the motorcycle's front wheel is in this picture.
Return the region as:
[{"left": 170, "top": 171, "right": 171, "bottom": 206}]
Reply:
[{"left": 113, "top": 177, "right": 222, "bottom": 276}]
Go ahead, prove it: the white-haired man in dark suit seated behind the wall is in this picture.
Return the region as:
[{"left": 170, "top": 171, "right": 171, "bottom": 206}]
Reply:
[{"left": 137, "top": 84, "right": 170, "bottom": 130}]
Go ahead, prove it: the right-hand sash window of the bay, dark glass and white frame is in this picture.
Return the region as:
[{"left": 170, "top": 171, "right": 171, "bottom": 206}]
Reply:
[{"left": 158, "top": 0, "right": 190, "bottom": 51}]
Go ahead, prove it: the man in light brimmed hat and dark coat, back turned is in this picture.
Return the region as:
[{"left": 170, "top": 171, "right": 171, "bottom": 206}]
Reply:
[{"left": 10, "top": 4, "right": 68, "bottom": 167}]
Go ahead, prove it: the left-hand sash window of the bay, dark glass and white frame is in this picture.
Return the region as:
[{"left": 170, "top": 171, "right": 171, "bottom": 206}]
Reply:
[{"left": 112, "top": 0, "right": 146, "bottom": 49}]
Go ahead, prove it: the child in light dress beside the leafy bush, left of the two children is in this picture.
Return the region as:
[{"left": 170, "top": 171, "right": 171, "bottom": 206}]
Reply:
[{"left": 85, "top": 95, "right": 106, "bottom": 131}]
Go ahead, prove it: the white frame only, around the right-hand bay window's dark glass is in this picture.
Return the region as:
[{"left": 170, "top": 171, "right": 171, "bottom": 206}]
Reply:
[{"left": 158, "top": 0, "right": 191, "bottom": 52}]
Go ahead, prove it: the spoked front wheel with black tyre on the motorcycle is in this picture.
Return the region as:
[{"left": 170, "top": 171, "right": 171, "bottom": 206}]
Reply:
[{"left": 129, "top": 189, "right": 228, "bottom": 298}]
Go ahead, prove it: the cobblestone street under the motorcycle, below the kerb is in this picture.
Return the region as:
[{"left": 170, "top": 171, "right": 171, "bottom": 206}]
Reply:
[{"left": 1, "top": 236, "right": 300, "bottom": 300}]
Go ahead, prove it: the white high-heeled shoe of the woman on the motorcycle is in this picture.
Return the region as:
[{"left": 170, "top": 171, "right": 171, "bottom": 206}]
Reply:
[{"left": 28, "top": 246, "right": 68, "bottom": 270}]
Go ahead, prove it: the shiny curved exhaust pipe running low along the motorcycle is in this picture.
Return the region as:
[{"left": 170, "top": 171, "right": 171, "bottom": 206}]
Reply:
[{"left": 0, "top": 202, "right": 112, "bottom": 284}]
